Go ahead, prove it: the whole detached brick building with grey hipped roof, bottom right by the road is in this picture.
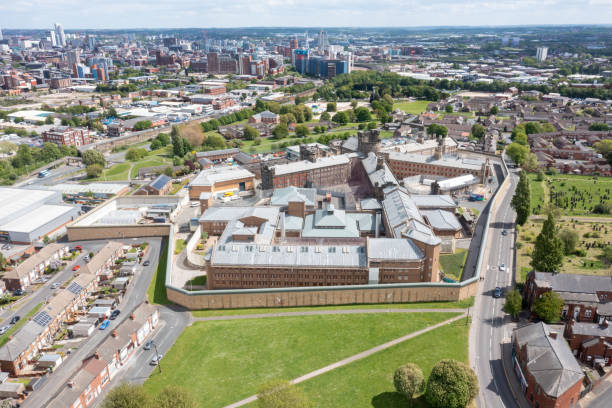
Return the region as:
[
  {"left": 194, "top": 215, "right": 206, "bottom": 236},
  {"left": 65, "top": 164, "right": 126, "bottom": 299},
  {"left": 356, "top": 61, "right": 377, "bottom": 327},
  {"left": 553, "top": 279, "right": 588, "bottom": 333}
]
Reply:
[{"left": 512, "top": 322, "right": 584, "bottom": 408}]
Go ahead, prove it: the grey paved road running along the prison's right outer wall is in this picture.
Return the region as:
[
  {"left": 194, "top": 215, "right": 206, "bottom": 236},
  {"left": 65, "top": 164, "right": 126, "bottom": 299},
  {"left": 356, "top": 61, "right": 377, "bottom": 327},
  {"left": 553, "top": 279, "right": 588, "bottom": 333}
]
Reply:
[{"left": 470, "top": 173, "right": 518, "bottom": 408}]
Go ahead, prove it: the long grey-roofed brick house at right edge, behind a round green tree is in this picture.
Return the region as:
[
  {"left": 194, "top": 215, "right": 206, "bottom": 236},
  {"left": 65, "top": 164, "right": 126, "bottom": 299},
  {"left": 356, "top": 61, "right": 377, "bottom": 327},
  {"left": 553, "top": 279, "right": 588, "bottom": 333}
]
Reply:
[{"left": 523, "top": 271, "right": 612, "bottom": 322}]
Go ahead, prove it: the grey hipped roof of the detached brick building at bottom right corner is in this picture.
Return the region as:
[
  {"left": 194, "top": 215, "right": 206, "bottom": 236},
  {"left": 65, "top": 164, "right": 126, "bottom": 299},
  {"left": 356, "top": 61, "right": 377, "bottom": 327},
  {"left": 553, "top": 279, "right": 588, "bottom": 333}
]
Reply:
[{"left": 514, "top": 322, "right": 584, "bottom": 397}]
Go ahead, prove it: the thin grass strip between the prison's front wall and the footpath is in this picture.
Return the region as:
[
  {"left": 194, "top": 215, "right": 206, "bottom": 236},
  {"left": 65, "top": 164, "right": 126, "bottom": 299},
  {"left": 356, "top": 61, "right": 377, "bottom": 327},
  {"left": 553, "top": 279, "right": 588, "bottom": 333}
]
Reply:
[{"left": 191, "top": 297, "right": 474, "bottom": 317}]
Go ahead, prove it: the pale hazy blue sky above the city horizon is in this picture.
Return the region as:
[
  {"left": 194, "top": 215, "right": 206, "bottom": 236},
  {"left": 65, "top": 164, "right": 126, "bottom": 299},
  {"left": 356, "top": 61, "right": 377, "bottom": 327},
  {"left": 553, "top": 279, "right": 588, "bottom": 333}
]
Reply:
[{"left": 0, "top": 0, "right": 612, "bottom": 29}]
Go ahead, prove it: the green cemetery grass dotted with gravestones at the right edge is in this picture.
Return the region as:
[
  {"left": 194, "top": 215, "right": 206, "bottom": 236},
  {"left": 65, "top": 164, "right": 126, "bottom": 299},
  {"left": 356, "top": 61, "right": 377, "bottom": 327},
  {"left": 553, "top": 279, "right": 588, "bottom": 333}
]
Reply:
[{"left": 529, "top": 174, "right": 612, "bottom": 216}]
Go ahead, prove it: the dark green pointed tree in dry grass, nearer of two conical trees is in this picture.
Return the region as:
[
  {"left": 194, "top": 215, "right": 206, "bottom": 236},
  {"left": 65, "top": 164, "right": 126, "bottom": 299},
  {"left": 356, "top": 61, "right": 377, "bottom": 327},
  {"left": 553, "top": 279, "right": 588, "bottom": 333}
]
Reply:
[{"left": 531, "top": 212, "right": 564, "bottom": 272}]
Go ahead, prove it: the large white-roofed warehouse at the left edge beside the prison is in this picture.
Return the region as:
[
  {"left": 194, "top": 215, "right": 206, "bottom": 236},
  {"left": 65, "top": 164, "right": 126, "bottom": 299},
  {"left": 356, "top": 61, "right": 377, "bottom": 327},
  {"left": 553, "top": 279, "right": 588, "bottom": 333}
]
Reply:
[{"left": 0, "top": 187, "right": 79, "bottom": 244}]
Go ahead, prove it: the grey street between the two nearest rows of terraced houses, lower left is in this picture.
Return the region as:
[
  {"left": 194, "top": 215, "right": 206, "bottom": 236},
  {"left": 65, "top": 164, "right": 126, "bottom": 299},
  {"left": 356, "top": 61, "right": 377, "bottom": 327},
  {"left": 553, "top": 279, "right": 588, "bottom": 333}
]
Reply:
[{"left": 22, "top": 238, "right": 161, "bottom": 408}]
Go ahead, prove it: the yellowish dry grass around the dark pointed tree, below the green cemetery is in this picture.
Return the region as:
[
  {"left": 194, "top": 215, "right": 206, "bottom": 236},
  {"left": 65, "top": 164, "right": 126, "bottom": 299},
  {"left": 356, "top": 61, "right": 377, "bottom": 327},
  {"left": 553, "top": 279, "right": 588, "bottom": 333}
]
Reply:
[{"left": 516, "top": 217, "right": 612, "bottom": 282}]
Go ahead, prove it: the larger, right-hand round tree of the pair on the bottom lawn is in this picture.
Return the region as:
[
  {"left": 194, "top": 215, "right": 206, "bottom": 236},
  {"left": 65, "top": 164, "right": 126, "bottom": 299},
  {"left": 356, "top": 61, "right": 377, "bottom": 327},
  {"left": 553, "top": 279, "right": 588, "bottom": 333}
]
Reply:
[{"left": 425, "top": 360, "right": 478, "bottom": 408}]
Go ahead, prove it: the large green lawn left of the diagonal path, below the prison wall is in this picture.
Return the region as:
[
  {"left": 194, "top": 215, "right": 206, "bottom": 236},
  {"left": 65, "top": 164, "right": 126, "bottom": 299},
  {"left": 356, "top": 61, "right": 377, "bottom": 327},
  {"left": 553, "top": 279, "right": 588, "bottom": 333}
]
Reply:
[{"left": 144, "top": 313, "right": 465, "bottom": 408}]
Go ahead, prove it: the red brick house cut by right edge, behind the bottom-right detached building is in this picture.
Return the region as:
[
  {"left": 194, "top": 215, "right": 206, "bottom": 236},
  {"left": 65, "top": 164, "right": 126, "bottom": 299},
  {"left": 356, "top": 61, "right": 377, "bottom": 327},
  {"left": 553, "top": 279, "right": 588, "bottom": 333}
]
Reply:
[{"left": 564, "top": 319, "right": 612, "bottom": 366}]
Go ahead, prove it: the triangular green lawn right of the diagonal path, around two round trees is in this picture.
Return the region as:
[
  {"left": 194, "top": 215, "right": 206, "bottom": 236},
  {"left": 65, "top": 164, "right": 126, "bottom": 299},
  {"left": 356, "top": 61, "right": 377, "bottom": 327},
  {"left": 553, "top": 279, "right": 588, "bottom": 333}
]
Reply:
[{"left": 299, "top": 319, "right": 470, "bottom": 408}]
